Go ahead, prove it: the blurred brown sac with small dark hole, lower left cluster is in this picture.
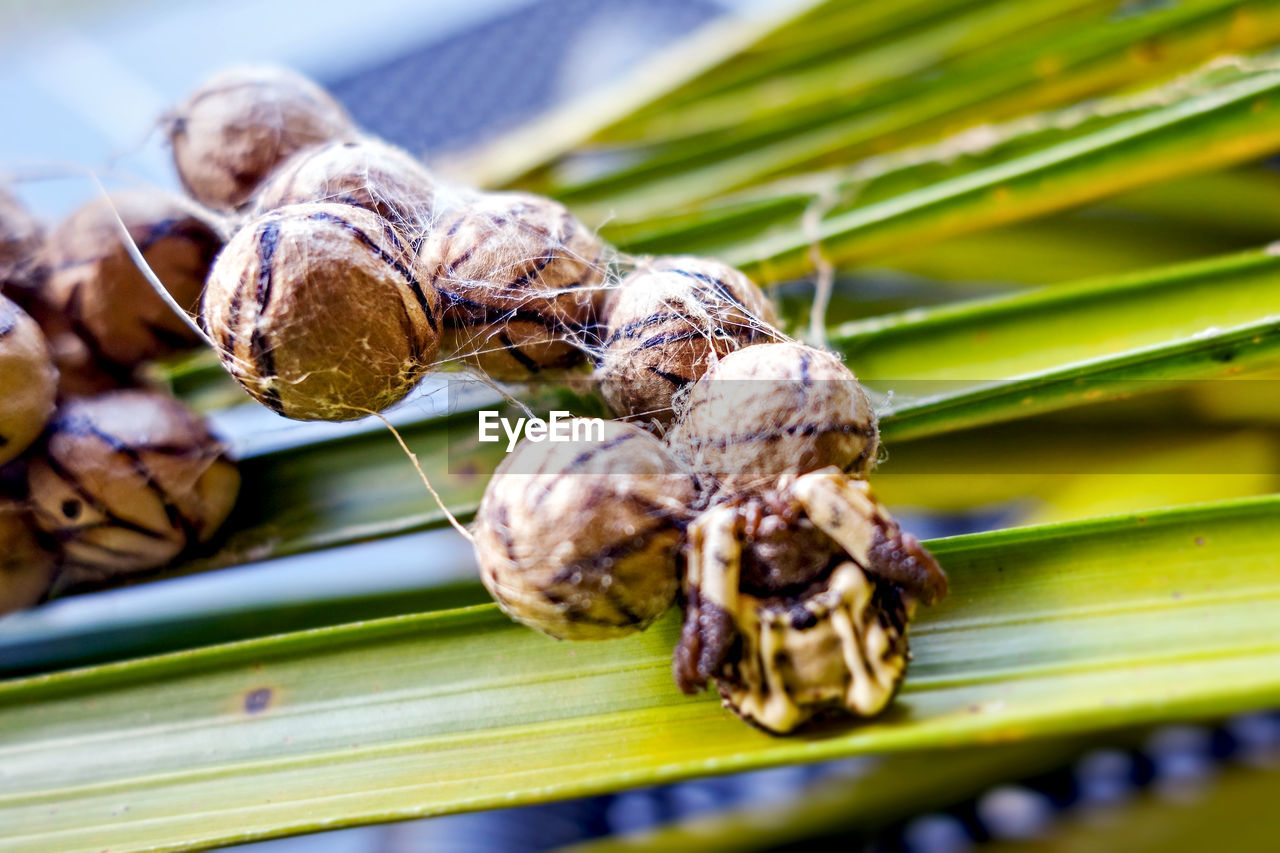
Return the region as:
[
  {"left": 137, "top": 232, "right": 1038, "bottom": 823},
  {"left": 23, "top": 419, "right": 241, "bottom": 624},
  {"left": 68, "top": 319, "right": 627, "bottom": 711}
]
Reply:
[{"left": 27, "top": 391, "right": 239, "bottom": 580}]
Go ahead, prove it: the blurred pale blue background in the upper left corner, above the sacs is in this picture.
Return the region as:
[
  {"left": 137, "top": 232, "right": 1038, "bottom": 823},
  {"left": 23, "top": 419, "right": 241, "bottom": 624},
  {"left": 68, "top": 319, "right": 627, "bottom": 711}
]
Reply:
[{"left": 0, "top": 0, "right": 757, "bottom": 216}]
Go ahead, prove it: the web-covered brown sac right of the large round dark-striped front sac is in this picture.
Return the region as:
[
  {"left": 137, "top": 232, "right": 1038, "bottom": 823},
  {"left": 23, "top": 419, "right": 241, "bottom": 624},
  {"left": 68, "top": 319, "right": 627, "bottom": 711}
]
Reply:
[{"left": 417, "top": 192, "right": 604, "bottom": 380}]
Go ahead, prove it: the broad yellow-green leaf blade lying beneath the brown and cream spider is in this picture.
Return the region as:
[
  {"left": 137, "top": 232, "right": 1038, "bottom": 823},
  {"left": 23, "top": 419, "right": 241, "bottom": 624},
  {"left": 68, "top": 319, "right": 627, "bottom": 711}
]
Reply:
[{"left": 0, "top": 498, "right": 1280, "bottom": 852}]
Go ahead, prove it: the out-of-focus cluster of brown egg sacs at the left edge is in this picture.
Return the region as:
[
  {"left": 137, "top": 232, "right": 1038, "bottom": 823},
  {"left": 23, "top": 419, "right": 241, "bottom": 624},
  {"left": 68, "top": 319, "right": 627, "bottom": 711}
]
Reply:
[{"left": 0, "top": 185, "right": 239, "bottom": 612}]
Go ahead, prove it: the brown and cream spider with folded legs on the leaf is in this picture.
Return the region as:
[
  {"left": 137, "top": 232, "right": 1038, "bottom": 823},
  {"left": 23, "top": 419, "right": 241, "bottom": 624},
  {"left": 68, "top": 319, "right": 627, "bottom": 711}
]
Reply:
[{"left": 673, "top": 467, "right": 946, "bottom": 733}]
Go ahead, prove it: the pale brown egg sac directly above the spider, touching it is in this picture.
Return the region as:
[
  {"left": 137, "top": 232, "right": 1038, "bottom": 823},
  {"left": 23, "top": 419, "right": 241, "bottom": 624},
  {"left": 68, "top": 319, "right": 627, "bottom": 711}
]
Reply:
[{"left": 667, "top": 343, "right": 879, "bottom": 492}]
